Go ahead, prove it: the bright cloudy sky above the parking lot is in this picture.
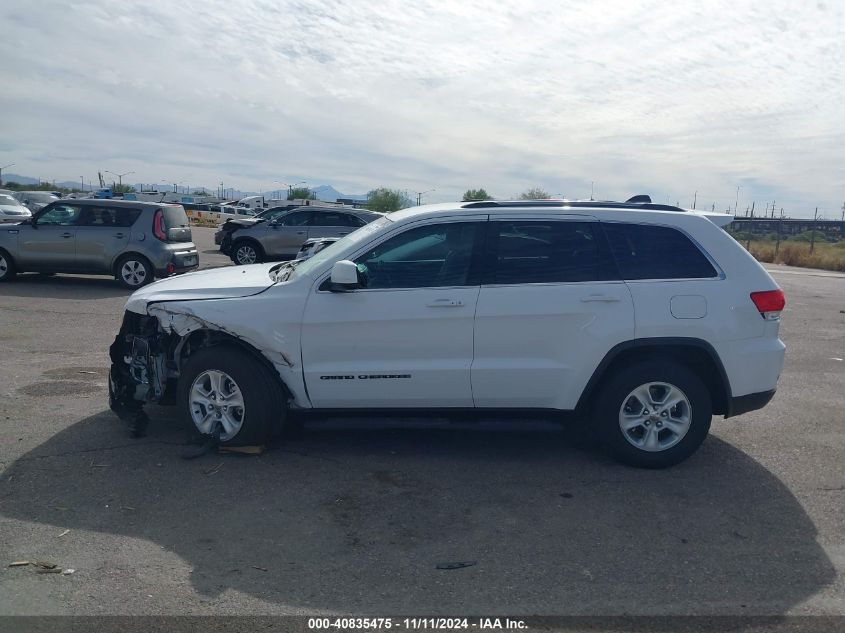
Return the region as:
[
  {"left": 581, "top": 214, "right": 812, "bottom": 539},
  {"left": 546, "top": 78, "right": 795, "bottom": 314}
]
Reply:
[{"left": 0, "top": 0, "right": 845, "bottom": 217}]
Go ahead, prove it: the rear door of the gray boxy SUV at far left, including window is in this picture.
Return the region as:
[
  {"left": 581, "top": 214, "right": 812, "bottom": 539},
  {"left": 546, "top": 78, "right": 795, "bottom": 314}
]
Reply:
[{"left": 76, "top": 205, "right": 141, "bottom": 273}]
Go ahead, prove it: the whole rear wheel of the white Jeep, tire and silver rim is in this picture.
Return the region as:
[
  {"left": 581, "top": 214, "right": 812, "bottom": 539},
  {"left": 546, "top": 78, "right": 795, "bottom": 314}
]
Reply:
[{"left": 595, "top": 360, "right": 713, "bottom": 468}]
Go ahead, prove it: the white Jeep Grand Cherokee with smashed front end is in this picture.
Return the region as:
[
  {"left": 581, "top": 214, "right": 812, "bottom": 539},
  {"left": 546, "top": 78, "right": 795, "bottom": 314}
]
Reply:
[{"left": 110, "top": 197, "right": 784, "bottom": 467}]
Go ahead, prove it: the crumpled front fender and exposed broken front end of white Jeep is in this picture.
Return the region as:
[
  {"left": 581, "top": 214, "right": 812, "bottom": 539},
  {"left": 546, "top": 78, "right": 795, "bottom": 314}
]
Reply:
[{"left": 109, "top": 303, "right": 294, "bottom": 437}]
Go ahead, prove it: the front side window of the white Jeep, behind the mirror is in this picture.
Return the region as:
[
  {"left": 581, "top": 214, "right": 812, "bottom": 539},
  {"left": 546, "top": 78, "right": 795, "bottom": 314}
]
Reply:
[{"left": 356, "top": 222, "right": 483, "bottom": 289}]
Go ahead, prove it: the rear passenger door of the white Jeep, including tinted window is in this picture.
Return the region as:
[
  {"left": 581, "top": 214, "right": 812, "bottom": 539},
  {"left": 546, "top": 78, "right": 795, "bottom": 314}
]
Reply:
[{"left": 472, "top": 215, "right": 634, "bottom": 409}]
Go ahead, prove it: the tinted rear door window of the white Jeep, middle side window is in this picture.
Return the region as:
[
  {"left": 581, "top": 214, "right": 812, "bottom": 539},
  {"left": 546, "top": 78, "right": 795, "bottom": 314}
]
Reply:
[{"left": 486, "top": 220, "right": 613, "bottom": 284}]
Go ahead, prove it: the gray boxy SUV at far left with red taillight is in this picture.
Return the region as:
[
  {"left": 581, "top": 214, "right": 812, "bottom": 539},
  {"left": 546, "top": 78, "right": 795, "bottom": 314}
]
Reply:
[{"left": 0, "top": 200, "right": 199, "bottom": 288}]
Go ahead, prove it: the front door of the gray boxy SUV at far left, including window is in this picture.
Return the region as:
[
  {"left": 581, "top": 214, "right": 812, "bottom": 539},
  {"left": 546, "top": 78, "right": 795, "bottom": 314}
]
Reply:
[{"left": 18, "top": 202, "right": 81, "bottom": 272}]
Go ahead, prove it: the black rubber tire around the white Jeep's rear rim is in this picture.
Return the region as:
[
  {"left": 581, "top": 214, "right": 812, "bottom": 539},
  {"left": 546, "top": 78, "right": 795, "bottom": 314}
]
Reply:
[{"left": 593, "top": 359, "right": 713, "bottom": 468}]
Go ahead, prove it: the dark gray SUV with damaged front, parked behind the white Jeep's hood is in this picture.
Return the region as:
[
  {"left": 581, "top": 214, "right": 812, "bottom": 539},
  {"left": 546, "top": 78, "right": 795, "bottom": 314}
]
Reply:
[{"left": 220, "top": 206, "right": 381, "bottom": 264}]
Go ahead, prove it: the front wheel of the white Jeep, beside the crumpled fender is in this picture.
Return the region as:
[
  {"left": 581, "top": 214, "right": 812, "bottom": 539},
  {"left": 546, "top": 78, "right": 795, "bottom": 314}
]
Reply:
[{"left": 178, "top": 345, "right": 286, "bottom": 446}]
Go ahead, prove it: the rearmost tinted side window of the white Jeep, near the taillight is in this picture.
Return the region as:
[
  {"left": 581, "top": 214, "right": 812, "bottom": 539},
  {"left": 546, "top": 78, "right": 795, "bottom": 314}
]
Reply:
[{"left": 603, "top": 222, "right": 718, "bottom": 279}]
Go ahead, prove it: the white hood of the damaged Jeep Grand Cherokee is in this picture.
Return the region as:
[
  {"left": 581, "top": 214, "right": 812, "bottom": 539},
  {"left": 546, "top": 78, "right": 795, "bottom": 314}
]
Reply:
[{"left": 126, "top": 263, "right": 278, "bottom": 314}]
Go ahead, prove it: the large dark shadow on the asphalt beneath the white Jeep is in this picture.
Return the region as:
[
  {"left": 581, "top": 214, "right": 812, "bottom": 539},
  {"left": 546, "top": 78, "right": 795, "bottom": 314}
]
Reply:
[{"left": 0, "top": 409, "right": 835, "bottom": 615}]
